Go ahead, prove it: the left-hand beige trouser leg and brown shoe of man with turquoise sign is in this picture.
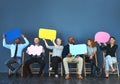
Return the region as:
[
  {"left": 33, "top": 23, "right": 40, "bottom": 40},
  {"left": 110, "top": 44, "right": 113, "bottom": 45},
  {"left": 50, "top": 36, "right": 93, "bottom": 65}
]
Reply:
[{"left": 63, "top": 57, "right": 73, "bottom": 79}]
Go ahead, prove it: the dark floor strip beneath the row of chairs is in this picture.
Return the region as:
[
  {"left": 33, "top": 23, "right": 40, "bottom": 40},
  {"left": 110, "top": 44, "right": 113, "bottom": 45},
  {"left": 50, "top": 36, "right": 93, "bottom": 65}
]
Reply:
[{"left": 0, "top": 74, "right": 120, "bottom": 84}]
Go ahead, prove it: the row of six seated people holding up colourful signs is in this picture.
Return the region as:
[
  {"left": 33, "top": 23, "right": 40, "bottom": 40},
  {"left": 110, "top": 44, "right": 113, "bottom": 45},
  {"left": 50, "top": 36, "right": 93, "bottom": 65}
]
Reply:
[{"left": 3, "top": 34, "right": 118, "bottom": 79}]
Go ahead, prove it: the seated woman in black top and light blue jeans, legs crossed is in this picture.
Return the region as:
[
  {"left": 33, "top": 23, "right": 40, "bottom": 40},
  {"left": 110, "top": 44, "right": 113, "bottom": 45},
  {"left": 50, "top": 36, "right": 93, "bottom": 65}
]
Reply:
[{"left": 99, "top": 37, "right": 118, "bottom": 78}]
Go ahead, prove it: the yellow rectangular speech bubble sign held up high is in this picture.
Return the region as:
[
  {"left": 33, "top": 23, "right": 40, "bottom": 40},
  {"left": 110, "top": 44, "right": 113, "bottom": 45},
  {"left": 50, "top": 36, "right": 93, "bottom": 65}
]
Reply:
[{"left": 39, "top": 28, "right": 57, "bottom": 40}]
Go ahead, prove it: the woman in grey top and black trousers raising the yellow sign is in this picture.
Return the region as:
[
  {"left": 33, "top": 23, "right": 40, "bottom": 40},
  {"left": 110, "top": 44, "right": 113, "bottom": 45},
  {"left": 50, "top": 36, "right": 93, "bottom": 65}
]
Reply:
[{"left": 43, "top": 38, "right": 63, "bottom": 78}]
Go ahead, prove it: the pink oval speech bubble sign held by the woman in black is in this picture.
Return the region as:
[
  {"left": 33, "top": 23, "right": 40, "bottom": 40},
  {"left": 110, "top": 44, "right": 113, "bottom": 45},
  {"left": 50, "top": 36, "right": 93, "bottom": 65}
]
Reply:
[{"left": 95, "top": 32, "right": 110, "bottom": 43}]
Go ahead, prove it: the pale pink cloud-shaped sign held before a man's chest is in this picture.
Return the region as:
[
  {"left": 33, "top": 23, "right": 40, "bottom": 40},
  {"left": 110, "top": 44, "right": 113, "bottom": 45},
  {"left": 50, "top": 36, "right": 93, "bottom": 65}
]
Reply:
[{"left": 27, "top": 45, "right": 43, "bottom": 56}]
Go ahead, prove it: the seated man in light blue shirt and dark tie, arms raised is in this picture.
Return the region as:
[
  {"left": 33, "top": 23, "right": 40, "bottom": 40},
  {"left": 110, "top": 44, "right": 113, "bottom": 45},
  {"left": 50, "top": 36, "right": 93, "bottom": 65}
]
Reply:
[{"left": 3, "top": 34, "right": 29, "bottom": 74}]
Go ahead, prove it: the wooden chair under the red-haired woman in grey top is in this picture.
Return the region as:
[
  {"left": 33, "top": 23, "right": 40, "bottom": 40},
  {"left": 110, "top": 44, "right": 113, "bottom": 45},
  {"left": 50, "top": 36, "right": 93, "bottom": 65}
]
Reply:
[{"left": 83, "top": 55, "right": 98, "bottom": 77}]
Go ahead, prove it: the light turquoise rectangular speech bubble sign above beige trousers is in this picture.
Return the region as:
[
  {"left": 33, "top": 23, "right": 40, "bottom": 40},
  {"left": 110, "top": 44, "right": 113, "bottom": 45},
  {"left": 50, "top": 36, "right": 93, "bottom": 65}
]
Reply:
[{"left": 70, "top": 44, "right": 87, "bottom": 56}]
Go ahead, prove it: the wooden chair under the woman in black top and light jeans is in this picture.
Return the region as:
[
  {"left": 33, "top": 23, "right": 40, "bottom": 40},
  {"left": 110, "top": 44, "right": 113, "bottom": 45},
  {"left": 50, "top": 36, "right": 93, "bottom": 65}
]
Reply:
[{"left": 103, "top": 52, "right": 119, "bottom": 77}]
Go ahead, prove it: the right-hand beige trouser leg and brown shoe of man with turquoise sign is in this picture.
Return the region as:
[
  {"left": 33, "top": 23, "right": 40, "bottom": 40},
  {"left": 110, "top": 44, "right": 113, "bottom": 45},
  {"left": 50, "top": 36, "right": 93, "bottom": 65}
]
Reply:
[{"left": 73, "top": 57, "right": 83, "bottom": 79}]
